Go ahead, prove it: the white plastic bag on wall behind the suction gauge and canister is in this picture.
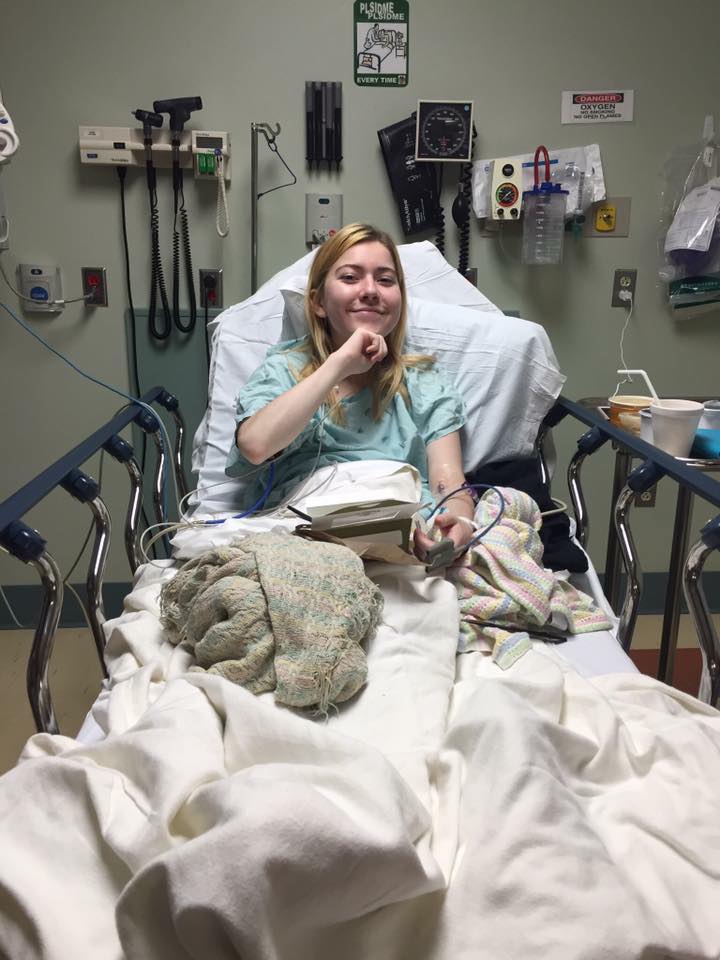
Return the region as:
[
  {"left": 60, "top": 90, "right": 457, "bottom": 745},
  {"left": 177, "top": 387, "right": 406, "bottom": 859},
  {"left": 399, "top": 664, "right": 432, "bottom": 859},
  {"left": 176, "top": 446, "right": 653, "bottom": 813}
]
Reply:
[{"left": 472, "top": 143, "right": 606, "bottom": 219}]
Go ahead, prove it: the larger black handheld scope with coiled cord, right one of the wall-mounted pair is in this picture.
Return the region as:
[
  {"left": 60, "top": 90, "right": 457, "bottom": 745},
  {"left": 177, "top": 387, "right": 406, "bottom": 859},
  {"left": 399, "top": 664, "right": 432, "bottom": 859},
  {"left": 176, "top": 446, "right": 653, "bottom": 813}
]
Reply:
[{"left": 153, "top": 97, "right": 202, "bottom": 333}]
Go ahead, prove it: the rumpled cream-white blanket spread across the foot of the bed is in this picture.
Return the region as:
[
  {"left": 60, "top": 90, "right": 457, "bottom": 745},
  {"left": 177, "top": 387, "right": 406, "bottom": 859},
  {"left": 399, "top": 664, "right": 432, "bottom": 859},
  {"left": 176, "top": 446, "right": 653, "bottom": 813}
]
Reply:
[{"left": 0, "top": 544, "right": 720, "bottom": 960}]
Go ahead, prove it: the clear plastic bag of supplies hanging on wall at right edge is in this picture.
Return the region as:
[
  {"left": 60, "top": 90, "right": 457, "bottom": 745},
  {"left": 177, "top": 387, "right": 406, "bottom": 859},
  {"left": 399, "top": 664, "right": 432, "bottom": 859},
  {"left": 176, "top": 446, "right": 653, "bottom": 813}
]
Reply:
[{"left": 658, "top": 117, "right": 720, "bottom": 318}]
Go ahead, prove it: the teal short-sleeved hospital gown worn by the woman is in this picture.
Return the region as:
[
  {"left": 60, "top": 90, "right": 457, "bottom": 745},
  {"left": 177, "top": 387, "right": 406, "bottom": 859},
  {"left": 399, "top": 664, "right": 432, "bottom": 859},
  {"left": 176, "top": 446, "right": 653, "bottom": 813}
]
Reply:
[{"left": 225, "top": 340, "right": 465, "bottom": 507}]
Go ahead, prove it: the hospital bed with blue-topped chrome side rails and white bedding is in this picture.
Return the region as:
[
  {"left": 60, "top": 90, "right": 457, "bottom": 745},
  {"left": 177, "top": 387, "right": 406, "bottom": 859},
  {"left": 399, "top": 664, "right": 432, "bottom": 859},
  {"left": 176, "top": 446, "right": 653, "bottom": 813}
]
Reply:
[{"left": 0, "top": 244, "right": 720, "bottom": 960}]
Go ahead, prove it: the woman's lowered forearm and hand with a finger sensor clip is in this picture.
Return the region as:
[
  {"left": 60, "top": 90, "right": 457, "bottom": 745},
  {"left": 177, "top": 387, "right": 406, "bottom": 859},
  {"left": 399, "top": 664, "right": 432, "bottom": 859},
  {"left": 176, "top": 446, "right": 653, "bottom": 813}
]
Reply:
[{"left": 415, "top": 430, "right": 475, "bottom": 555}]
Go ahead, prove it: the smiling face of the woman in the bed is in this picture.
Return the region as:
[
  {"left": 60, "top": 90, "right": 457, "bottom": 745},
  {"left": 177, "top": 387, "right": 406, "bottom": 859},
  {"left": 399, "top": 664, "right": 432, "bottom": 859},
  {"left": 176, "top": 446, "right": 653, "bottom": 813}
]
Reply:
[{"left": 313, "top": 240, "right": 402, "bottom": 349}]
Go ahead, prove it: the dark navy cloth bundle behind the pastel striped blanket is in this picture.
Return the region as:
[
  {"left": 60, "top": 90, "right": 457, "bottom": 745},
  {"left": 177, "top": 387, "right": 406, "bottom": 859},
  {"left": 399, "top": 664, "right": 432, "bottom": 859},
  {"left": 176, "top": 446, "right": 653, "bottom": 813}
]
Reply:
[{"left": 467, "top": 457, "right": 588, "bottom": 573}]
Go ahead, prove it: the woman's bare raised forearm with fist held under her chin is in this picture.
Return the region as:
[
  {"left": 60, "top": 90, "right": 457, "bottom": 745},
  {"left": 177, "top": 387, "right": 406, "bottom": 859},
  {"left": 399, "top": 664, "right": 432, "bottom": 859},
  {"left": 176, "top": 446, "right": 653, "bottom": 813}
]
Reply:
[{"left": 235, "top": 330, "right": 387, "bottom": 463}]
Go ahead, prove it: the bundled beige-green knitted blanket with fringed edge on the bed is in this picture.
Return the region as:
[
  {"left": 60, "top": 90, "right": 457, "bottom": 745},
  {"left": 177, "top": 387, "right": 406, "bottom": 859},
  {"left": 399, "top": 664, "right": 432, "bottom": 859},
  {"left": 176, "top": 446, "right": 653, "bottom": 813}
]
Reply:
[{"left": 160, "top": 532, "right": 383, "bottom": 712}]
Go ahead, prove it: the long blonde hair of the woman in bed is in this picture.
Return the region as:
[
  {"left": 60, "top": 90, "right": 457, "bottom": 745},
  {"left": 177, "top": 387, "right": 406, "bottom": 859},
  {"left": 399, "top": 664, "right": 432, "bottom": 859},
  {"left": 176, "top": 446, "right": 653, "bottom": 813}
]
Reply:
[{"left": 298, "top": 223, "right": 435, "bottom": 425}]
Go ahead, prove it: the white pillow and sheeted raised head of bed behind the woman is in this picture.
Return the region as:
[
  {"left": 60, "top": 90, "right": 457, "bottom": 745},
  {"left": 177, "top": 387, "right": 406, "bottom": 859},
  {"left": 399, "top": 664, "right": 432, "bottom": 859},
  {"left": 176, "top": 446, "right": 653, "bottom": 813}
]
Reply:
[{"left": 192, "top": 242, "right": 565, "bottom": 511}]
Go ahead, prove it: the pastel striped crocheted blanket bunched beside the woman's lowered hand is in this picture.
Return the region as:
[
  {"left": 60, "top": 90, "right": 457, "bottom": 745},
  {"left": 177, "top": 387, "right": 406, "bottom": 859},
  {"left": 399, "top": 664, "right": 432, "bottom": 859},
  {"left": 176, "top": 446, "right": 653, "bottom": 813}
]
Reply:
[{"left": 447, "top": 487, "right": 611, "bottom": 668}]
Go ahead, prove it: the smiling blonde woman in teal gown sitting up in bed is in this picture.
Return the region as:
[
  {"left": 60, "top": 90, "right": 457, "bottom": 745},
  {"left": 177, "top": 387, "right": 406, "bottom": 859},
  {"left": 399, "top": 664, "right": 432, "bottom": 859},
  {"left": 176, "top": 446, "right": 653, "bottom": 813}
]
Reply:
[{"left": 227, "top": 224, "right": 474, "bottom": 559}]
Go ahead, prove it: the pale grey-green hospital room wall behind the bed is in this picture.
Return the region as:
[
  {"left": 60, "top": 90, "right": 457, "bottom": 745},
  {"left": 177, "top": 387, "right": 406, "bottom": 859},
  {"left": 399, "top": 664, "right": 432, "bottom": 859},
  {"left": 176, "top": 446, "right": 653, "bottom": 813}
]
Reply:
[{"left": 0, "top": 0, "right": 720, "bottom": 584}]
